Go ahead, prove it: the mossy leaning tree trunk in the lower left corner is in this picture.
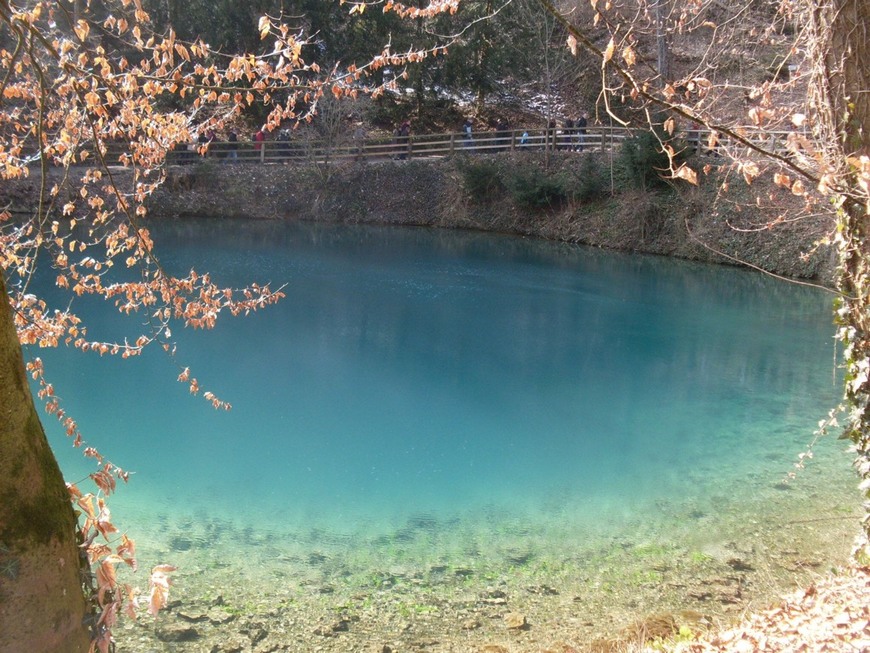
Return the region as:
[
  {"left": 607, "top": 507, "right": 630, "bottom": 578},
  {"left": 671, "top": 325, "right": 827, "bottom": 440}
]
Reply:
[{"left": 0, "top": 273, "right": 90, "bottom": 653}]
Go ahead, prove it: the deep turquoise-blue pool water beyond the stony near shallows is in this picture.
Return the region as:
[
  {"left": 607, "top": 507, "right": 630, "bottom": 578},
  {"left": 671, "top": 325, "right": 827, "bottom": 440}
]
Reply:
[{"left": 32, "top": 221, "right": 849, "bottom": 564}]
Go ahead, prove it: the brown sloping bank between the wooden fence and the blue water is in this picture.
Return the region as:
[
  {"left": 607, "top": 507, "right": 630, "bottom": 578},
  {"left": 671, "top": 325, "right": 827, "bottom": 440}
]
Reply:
[{"left": 140, "top": 152, "right": 836, "bottom": 285}]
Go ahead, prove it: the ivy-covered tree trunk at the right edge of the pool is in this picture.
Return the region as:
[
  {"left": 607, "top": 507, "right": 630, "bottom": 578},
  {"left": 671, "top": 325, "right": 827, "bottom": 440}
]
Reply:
[{"left": 809, "top": 0, "right": 870, "bottom": 563}]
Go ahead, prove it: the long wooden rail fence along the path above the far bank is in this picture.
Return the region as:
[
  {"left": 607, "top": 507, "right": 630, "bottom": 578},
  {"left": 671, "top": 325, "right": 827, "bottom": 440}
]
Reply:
[{"left": 108, "top": 127, "right": 812, "bottom": 164}]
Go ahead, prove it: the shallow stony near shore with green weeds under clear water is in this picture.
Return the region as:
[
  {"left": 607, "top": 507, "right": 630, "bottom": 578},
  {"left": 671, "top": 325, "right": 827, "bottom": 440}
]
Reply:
[{"left": 109, "top": 443, "right": 858, "bottom": 653}]
